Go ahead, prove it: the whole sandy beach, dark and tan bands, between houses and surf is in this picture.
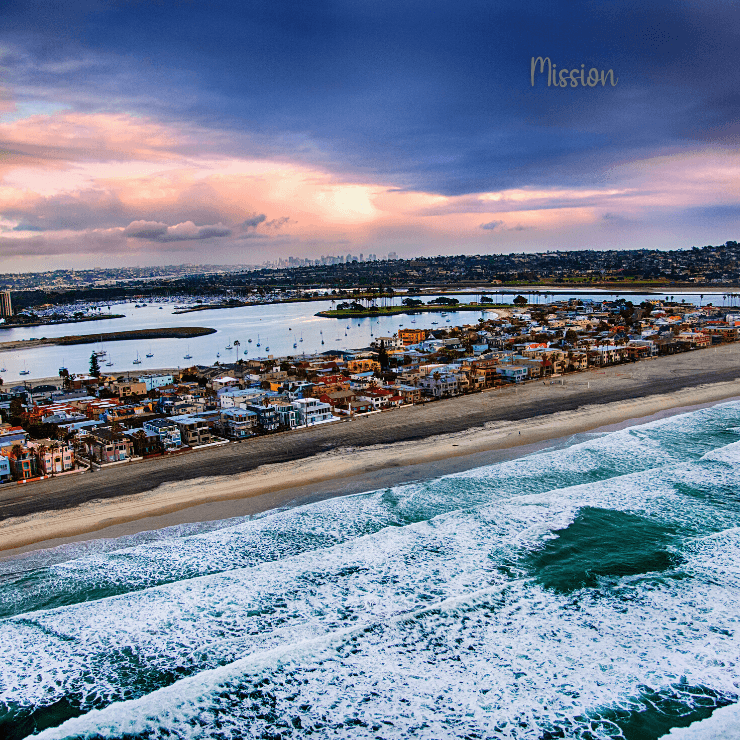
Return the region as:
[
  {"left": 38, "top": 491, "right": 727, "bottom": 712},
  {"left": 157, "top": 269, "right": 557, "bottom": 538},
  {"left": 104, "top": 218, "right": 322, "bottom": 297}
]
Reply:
[{"left": 0, "top": 345, "right": 740, "bottom": 556}]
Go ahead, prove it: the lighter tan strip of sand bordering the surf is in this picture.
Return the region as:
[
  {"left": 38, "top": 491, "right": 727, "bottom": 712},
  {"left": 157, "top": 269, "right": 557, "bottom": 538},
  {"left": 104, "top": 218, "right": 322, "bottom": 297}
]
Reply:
[{"left": 0, "top": 368, "right": 740, "bottom": 559}]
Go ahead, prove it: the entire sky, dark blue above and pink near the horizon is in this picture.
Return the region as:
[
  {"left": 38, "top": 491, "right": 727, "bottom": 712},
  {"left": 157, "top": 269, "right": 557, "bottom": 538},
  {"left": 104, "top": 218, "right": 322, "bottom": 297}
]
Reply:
[{"left": 0, "top": 0, "right": 740, "bottom": 271}]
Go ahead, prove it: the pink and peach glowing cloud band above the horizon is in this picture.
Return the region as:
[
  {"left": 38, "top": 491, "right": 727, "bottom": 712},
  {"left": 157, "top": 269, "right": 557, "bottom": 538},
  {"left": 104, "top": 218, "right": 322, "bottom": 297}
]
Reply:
[{"left": 0, "top": 108, "right": 740, "bottom": 268}]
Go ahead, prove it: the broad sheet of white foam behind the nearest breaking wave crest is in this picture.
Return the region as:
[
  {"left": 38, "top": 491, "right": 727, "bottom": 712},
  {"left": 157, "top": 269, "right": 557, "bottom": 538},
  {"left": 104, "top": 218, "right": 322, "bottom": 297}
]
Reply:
[{"left": 24, "top": 581, "right": 737, "bottom": 738}]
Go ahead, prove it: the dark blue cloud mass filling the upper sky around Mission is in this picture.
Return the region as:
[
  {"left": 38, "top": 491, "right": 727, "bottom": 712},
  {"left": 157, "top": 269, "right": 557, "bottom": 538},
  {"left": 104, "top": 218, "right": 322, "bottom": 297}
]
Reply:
[{"left": 0, "top": 0, "right": 740, "bottom": 194}]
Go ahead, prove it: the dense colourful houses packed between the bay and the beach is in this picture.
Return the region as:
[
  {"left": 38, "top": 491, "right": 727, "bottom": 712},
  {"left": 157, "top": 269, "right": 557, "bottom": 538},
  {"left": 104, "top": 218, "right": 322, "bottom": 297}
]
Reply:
[{"left": 0, "top": 299, "right": 740, "bottom": 482}]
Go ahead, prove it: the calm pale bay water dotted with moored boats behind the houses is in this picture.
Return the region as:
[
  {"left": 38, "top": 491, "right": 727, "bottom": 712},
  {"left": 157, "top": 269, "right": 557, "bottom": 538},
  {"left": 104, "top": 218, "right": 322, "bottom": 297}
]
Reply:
[{"left": 0, "top": 290, "right": 727, "bottom": 384}]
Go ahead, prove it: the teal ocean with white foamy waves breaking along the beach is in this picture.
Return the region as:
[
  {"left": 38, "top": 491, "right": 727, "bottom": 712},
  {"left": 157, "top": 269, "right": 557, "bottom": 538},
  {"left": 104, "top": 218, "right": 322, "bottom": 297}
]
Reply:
[{"left": 0, "top": 402, "right": 740, "bottom": 740}]
